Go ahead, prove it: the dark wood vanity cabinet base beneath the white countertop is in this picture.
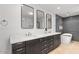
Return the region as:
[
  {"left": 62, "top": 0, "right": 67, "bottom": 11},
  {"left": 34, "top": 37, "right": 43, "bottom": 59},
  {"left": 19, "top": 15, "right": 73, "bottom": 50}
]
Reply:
[{"left": 12, "top": 34, "right": 61, "bottom": 54}]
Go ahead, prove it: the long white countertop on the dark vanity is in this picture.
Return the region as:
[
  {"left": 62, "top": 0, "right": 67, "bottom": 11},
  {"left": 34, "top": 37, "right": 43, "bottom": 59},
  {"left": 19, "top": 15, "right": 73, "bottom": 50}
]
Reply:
[{"left": 10, "top": 32, "right": 61, "bottom": 44}]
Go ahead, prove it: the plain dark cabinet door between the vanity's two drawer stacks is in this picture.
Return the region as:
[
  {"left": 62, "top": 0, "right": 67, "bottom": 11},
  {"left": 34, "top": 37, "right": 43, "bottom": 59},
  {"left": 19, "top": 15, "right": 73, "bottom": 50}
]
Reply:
[{"left": 26, "top": 39, "right": 40, "bottom": 54}]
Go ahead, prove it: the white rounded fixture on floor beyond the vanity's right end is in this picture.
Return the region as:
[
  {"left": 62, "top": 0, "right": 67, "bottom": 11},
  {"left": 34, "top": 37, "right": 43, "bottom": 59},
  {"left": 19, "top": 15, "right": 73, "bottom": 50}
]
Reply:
[{"left": 61, "top": 33, "right": 72, "bottom": 44}]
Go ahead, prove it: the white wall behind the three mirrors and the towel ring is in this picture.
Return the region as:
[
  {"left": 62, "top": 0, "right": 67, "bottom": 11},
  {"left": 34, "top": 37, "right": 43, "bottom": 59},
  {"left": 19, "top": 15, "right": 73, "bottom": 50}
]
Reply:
[{"left": 0, "top": 4, "right": 55, "bottom": 53}]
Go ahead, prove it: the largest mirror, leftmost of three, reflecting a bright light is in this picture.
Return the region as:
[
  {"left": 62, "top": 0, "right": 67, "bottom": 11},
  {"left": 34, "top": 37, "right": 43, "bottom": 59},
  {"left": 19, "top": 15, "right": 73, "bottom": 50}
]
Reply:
[{"left": 21, "top": 4, "right": 34, "bottom": 29}]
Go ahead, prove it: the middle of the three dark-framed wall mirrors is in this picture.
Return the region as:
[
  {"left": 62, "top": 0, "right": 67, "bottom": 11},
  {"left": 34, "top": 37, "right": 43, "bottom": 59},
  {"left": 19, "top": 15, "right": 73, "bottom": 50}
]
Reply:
[{"left": 36, "top": 10, "right": 45, "bottom": 29}]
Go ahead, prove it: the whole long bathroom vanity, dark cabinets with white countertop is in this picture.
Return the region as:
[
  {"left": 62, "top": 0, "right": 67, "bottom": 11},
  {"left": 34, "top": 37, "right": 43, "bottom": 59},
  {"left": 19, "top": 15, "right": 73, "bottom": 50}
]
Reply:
[{"left": 10, "top": 33, "right": 61, "bottom": 54}]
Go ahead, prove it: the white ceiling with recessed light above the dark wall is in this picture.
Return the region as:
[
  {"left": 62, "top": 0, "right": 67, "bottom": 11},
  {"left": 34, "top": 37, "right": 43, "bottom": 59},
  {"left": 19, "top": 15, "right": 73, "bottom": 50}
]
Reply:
[{"left": 28, "top": 4, "right": 79, "bottom": 17}]
